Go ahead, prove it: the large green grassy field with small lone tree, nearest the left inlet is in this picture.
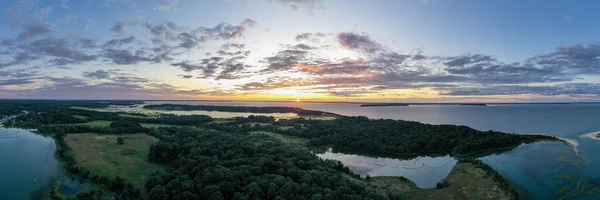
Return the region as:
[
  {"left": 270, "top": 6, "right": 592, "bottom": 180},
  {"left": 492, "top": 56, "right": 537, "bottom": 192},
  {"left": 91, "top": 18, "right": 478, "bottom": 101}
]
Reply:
[{"left": 65, "top": 133, "right": 164, "bottom": 186}]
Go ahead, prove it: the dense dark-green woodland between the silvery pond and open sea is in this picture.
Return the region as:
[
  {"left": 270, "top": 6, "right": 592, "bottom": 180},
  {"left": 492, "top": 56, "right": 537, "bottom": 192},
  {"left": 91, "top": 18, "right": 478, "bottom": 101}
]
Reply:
[{"left": 280, "top": 117, "right": 556, "bottom": 157}]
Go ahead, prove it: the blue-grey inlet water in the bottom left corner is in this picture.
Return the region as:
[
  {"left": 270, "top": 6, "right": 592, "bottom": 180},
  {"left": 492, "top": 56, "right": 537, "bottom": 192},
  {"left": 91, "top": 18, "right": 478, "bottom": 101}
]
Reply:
[{"left": 0, "top": 128, "right": 87, "bottom": 199}]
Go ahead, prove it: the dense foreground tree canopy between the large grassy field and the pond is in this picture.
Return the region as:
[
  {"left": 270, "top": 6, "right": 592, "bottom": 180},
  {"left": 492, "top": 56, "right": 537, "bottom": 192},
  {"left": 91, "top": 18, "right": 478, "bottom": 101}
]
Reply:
[{"left": 146, "top": 128, "right": 383, "bottom": 200}]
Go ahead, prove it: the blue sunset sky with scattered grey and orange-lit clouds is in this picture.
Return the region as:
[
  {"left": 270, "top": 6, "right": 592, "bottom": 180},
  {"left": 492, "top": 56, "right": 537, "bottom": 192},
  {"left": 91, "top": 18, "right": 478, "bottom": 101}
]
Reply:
[{"left": 0, "top": 0, "right": 600, "bottom": 102}]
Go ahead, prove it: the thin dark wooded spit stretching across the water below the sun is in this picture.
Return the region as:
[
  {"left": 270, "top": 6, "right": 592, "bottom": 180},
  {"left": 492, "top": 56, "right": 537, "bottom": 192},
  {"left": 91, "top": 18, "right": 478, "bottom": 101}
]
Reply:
[{"left": 144, "top": 104, "right": 339, "bottom": 116}]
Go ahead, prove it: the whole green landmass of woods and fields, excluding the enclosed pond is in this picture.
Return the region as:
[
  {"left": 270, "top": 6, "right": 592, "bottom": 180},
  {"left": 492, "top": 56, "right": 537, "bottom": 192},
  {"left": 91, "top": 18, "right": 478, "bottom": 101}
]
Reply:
[{"left": 0, "top": 102, "right": 576, "bottom": 199}]
